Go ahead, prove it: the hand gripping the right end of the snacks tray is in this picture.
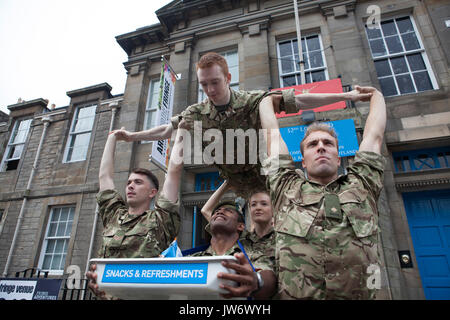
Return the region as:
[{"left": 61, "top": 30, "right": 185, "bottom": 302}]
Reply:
[{"left": 217, "top": 253, "right": 258, "bottom": 299}]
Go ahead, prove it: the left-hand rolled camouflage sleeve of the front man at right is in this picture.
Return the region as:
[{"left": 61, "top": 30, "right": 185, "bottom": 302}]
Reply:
[{"left": 262, "top": 154, "right": 299, "bottom": 211}]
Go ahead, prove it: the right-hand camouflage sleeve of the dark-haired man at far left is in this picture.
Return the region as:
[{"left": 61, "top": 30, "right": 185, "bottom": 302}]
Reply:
[{"left": 155, "top": 195, "right": 180, "bottom": 244}]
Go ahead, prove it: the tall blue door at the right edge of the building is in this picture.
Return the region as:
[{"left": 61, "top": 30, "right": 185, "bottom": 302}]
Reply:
[{"left": 403, "top": 190, "right": 450, "bottom": 300}]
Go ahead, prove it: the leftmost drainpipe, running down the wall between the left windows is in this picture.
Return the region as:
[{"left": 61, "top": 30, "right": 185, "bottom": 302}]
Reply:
[{"left": 2, "top": 116, "right": 50, "bottom": 277}]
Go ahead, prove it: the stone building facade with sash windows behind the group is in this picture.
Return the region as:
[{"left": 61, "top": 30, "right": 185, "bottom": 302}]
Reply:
[{"left": 0, "top": 0, "right": 450, "bottom": 299}]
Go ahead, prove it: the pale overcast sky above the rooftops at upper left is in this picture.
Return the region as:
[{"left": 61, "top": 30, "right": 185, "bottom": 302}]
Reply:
[{"left": 0, "top": 0, "right": 171, "bottom": 113}]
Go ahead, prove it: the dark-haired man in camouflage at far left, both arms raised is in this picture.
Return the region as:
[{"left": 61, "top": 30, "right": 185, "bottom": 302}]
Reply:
[{"left": 86, "top": 126, "right": 183, "bottom": 297}]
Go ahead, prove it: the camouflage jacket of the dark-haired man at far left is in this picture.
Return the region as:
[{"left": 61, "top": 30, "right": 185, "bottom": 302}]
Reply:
[{"left": 97, "top": 190, "right": 180, "bottom": 258}]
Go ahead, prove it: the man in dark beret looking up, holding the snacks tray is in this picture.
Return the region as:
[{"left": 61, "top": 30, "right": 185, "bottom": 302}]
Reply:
[{"left": 193, "top": 201, "right": 276, "bottom": 299}]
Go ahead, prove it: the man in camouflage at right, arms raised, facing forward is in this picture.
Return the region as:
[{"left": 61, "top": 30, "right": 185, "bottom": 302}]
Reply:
[{"left": 261, "top": 87, "right": 386, "bottom": 299}]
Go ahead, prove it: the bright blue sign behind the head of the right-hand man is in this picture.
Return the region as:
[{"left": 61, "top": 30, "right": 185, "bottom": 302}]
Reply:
[{"left": 280, "top": 119, "right": 359, "bottom": 162}]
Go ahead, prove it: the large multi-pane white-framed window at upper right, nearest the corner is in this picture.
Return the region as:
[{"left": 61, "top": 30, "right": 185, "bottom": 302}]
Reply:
[{"left": 366, "top": 16, "right": 438, "bottom": 96}]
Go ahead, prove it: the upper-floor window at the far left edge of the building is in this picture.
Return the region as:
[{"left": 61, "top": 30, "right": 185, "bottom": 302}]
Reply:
[{"left": 2, "top": 119, "right": 32, "bottom": 171}]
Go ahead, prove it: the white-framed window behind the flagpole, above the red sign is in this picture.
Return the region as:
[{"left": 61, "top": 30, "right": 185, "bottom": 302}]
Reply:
[{"left": 277, "top": 35, "right": 328, "bottom": 88}]
